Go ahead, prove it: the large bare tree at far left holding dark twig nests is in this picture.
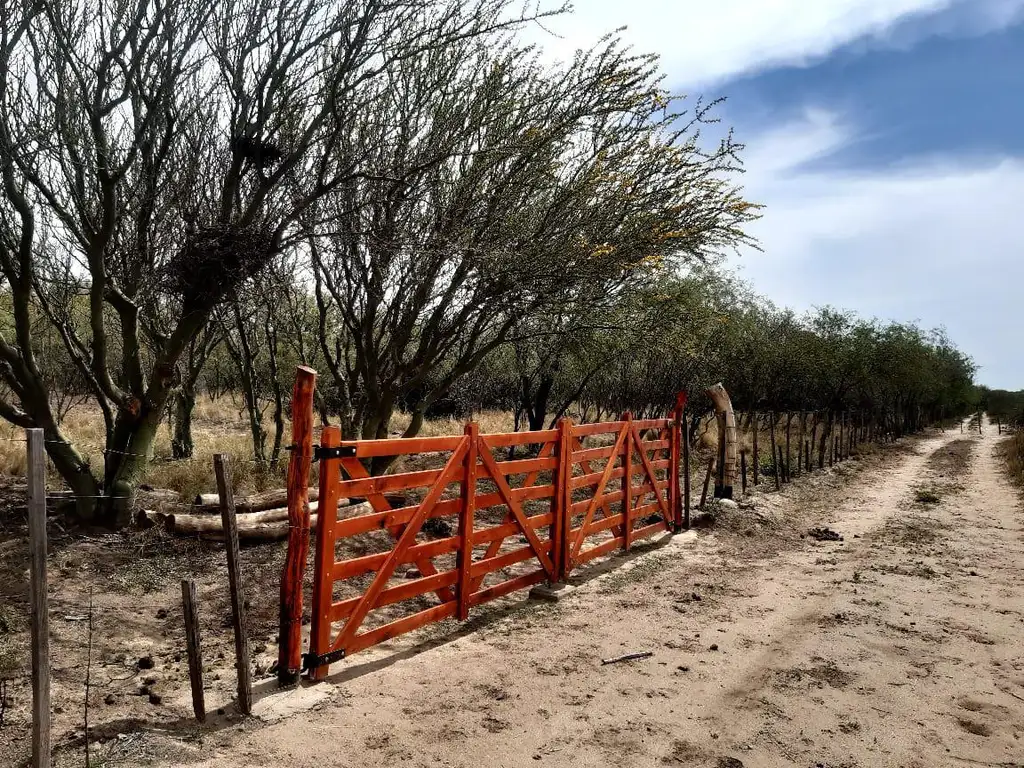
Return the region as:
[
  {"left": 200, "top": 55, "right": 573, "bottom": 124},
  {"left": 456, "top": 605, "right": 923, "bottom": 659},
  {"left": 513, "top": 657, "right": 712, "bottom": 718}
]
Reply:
[{"left": 0, "top": 0, "right": 544, "bottom": 524}]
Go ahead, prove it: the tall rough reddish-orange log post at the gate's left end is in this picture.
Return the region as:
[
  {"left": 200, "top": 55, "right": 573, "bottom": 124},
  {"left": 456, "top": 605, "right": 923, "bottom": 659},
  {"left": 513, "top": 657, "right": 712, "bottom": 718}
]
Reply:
[{"left": 278, "top": 366, "right": 313, "bottom": 685}]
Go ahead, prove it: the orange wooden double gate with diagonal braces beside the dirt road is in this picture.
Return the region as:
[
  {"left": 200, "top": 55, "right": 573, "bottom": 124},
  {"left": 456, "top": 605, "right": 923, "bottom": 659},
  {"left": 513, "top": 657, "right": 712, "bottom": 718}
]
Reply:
[{"left": 296, "top": 399, "right": 683, "bottom": 679}]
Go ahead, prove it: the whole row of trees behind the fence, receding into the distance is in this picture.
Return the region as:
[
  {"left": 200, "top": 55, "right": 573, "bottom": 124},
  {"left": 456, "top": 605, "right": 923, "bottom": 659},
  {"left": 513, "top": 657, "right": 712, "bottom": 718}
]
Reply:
[{"left": 0, "top": 0, "right": 971, "bottom": 524}]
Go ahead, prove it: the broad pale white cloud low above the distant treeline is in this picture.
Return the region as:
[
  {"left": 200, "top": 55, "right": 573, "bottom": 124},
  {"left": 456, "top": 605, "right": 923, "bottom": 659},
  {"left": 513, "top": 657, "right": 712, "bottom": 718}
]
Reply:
[{"left": 738, "top": 112, "right": 1024, "bottom": 388}]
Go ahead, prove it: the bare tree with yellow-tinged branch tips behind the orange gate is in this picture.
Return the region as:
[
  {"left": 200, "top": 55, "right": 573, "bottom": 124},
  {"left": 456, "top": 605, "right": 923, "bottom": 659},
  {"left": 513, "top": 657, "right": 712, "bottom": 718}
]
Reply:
[{"left": 307, "top": 34, "right": 756, "bottom": 462}]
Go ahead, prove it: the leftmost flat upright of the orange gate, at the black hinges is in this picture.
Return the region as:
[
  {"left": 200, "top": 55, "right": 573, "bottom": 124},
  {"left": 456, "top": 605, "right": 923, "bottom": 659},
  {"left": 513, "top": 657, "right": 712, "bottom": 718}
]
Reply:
[{"left": 309, "top": 427, "right": 341, "bottom": 680}]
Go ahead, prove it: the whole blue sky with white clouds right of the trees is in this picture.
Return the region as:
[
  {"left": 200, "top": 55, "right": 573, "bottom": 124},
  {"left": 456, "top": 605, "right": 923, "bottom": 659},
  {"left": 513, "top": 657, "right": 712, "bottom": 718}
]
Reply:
[{"left": 543, "top": 0, "right": 1024, "bottom": 389}]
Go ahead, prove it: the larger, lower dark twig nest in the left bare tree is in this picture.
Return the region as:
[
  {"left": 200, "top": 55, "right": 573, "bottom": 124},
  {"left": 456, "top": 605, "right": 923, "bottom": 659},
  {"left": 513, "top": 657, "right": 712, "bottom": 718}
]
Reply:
[{"left": 166, "top": 226, "right": 276, "bottom": 314}]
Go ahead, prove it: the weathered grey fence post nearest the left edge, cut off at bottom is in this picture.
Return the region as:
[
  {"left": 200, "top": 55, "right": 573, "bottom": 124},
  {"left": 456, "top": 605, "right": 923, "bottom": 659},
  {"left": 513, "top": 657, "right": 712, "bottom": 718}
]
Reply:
[{"left": 26, "top": 429, "right": 49, "bottom": 768}]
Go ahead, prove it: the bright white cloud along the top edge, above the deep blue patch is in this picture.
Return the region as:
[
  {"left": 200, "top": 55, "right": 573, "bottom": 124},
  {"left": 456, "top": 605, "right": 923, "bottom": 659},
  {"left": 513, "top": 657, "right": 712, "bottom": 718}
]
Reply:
[{"left": 530, "top": 0, "right": 954, "bottom": 86}]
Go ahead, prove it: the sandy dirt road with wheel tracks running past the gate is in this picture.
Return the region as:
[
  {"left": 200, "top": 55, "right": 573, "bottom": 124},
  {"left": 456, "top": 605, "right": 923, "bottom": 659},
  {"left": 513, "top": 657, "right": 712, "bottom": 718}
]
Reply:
[{"left": 161, "top": 428, "right": 1024, "bottom": 768}]
